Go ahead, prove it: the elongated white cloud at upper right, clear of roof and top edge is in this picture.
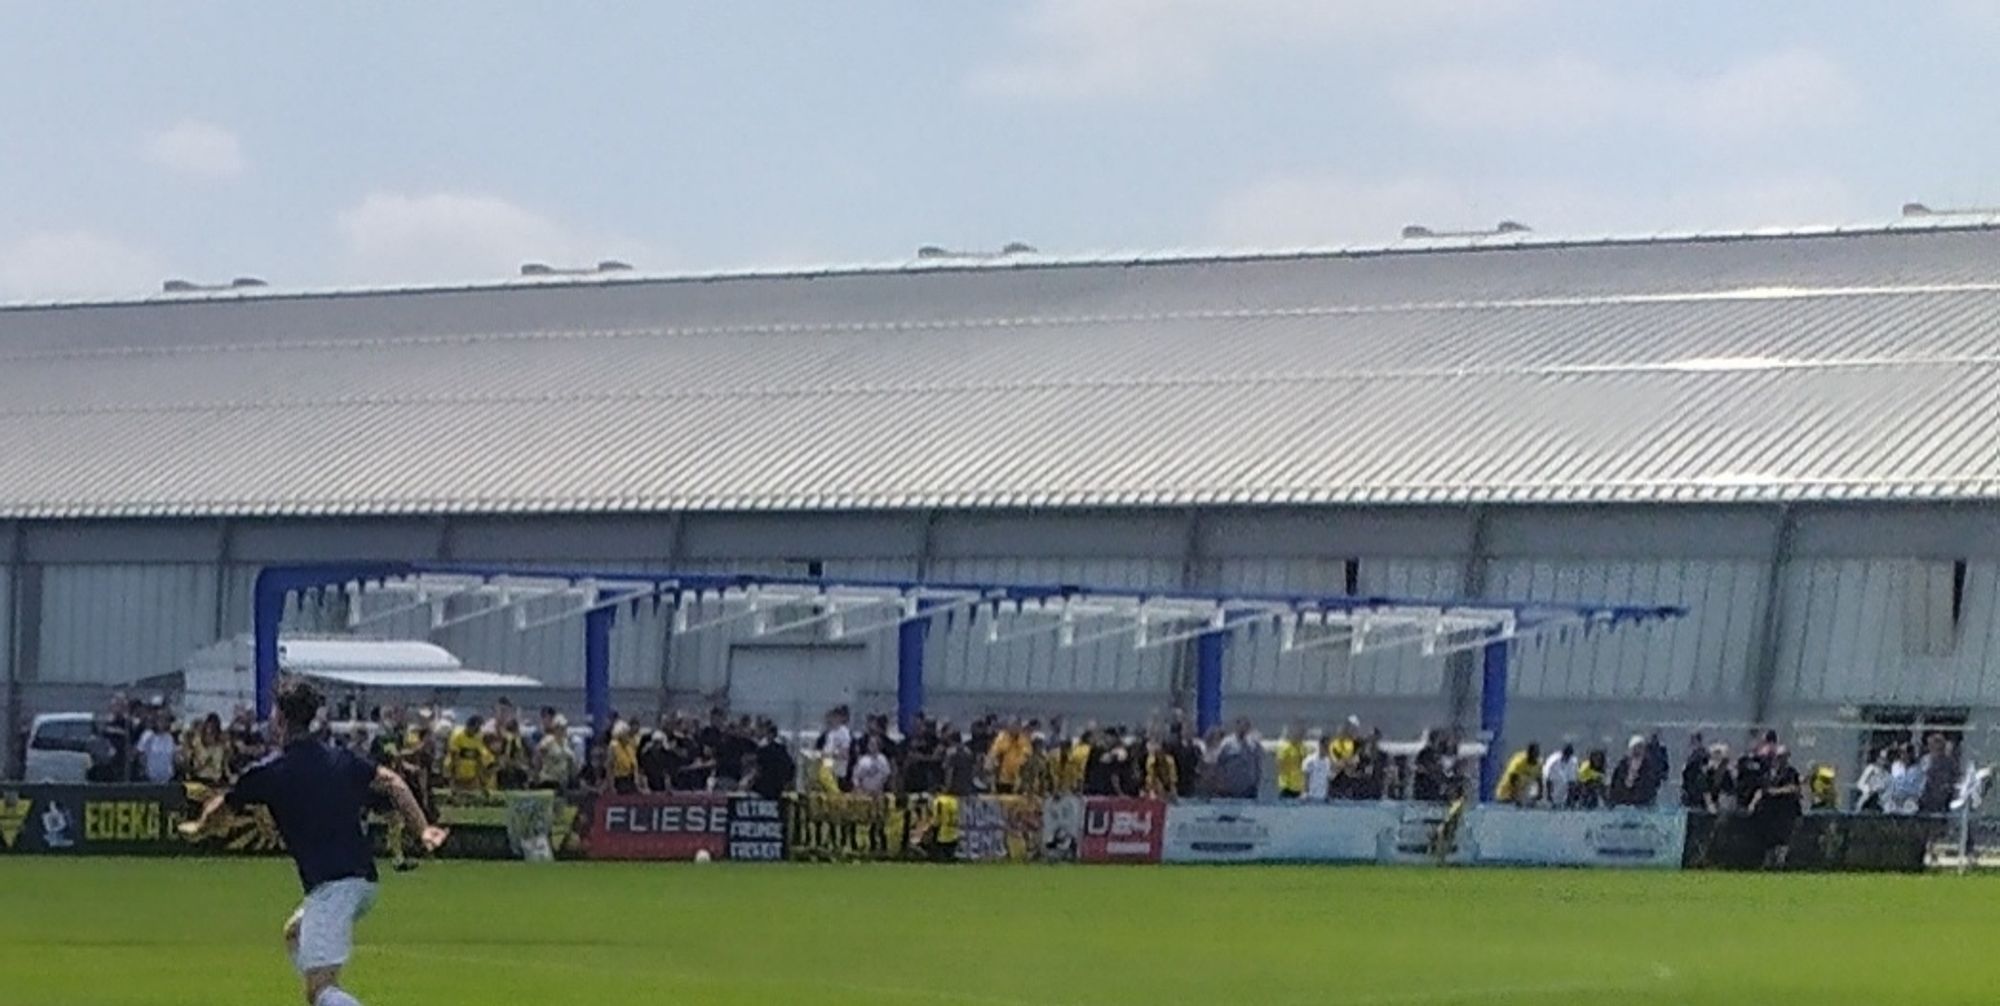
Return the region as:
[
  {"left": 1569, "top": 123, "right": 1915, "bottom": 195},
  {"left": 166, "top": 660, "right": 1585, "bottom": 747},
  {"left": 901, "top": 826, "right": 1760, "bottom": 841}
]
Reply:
[{"left": 1392, "top": 50, "right": 1860, "bottom": 140}]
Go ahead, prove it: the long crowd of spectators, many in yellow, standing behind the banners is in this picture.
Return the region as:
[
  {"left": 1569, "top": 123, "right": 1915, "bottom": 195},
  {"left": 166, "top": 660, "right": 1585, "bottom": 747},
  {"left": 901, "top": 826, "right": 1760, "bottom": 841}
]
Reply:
[{"left": 47, "top": 694, "right": 1962, "bottom": 832}]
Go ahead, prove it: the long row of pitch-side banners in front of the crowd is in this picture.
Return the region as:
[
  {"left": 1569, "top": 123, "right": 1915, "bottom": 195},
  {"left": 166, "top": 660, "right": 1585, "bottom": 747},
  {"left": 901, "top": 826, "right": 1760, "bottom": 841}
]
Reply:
[{"left": 0, "top": 784, "right": 1952, "bottom": 872}]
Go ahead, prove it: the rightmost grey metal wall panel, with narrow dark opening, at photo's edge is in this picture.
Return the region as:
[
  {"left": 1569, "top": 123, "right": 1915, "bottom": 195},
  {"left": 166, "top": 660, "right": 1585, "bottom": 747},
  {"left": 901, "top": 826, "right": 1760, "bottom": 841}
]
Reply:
[{"left": 1776, "top": 558, "right": 2000, "bottom": 706}]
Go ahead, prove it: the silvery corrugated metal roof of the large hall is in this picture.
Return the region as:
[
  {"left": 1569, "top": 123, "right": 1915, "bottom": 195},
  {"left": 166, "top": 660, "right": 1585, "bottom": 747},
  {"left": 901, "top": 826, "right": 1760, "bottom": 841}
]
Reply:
[{"left": 11, "top": 226, "right": 2000, "bottom": 518}]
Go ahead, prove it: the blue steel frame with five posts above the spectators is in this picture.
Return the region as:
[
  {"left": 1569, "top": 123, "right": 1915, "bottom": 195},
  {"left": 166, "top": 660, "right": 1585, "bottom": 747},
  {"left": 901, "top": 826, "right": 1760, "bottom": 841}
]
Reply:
[{"left": 252, "top": 562, "right": 1686, "bottom": 800}]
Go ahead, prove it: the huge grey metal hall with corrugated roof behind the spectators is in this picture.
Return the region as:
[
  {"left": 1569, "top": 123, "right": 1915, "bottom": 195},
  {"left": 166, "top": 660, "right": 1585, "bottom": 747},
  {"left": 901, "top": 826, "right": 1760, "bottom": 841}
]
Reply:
[{"left": 0, "top": 218, "right": 2000, "bottom": 772}]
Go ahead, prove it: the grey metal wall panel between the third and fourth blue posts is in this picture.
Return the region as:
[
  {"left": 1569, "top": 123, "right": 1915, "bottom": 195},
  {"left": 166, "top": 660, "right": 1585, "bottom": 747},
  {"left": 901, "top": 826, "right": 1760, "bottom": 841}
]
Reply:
[{"left": 924, "top": 558, "right": 1186, "bottom": 700}]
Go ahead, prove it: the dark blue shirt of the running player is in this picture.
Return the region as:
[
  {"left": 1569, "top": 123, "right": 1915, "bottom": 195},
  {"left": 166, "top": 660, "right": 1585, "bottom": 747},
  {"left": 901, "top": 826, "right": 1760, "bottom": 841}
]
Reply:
[{"left": 228, "top": 738, "right": 376, "bottom": 892}]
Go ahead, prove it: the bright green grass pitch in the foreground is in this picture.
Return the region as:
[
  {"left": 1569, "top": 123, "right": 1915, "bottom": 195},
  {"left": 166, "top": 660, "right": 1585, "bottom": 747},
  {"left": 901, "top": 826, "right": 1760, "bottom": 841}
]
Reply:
[{"left": 0, "top": 858, "right": 2000, "bottom": 1006}]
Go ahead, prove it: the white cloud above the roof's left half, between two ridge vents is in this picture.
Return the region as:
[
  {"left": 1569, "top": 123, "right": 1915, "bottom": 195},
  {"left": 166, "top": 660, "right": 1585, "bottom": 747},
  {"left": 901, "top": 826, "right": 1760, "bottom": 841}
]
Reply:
[{"left": 336, "top": 192, "right": 660, "bottom": 282}]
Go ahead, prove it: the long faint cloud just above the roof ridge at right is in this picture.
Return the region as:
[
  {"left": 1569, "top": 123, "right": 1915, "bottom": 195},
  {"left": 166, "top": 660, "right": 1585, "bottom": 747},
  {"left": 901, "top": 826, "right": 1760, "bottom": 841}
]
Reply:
[{"left": 1210, "top": 174, "right": 1882, "bottom": 246}]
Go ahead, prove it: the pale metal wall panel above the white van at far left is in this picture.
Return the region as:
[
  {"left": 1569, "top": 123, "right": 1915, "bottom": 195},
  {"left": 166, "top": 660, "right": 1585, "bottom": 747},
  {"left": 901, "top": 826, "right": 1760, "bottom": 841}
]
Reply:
[{"left": 38, "top": 564, "right": 220, "bottom": 684}]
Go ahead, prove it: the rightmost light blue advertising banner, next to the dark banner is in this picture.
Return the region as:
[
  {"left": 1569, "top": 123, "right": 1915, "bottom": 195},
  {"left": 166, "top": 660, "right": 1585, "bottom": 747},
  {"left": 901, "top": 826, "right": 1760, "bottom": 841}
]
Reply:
[{"left": 1466, "top": 806, "right": 1688, "bottom": 870}]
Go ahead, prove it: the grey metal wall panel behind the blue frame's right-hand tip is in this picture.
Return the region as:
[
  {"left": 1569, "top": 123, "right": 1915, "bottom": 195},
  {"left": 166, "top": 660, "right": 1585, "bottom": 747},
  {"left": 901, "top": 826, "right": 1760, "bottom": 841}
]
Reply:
[{"left": 1486, "top": 558, "right": 1764, "bottom": 702}]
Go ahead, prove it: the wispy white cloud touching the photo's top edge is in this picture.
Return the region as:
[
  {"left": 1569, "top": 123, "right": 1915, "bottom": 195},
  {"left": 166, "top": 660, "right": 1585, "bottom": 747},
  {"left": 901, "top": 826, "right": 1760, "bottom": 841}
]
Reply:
[{"left": 966, "top": 0, "right": 1522, "bottom": 98}]
